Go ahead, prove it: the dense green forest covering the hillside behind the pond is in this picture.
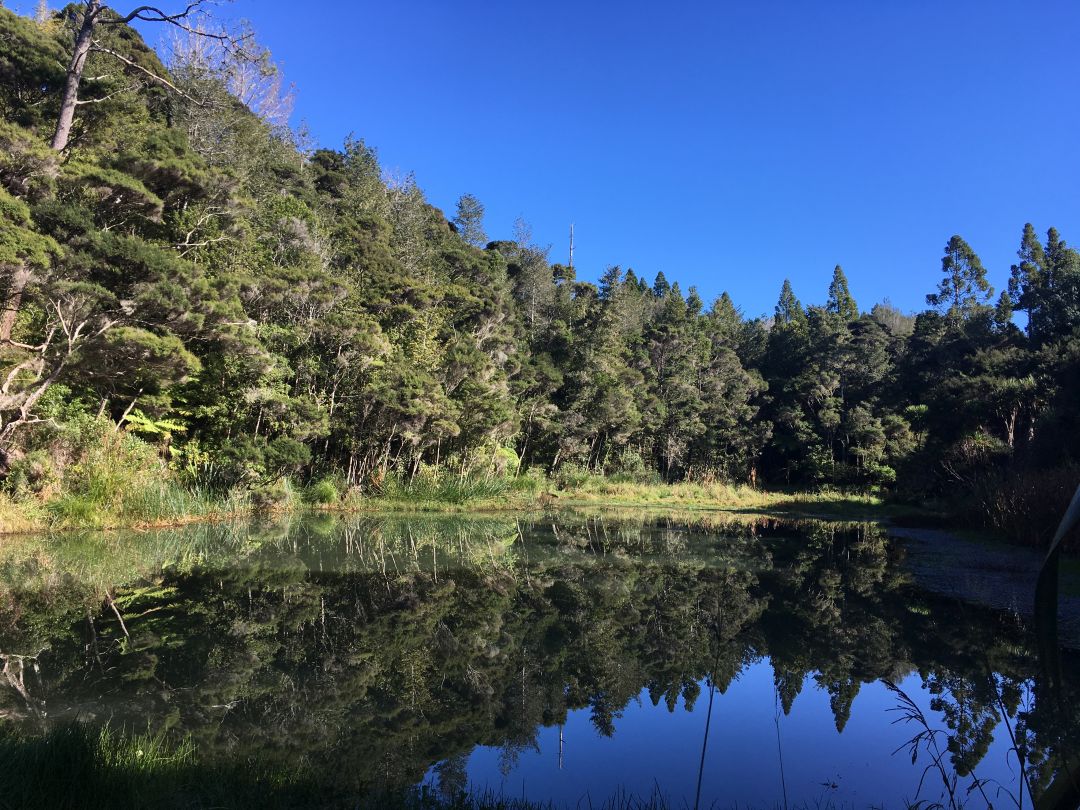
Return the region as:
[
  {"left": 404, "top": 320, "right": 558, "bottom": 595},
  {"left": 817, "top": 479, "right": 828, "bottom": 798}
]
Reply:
[{"left": 0, "top": 9, "right": 1080, "bottom": 535}]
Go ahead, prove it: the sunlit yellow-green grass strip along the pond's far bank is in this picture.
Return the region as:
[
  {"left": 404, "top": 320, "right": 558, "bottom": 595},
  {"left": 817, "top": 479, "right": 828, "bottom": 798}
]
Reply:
[{"left": 0, "top": 432, "right": 943, "bottom": 537}]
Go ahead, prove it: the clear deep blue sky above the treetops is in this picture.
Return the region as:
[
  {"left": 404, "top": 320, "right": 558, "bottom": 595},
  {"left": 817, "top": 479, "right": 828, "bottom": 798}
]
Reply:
[{"left": 118, "top": 0, "right": 1080, "bottom": 315}]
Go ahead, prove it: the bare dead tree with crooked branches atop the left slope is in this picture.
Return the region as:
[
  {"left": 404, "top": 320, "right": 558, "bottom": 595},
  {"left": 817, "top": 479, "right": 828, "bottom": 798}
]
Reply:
[{"left": 51, "top": 0, "right": 235, "bottom": 151}]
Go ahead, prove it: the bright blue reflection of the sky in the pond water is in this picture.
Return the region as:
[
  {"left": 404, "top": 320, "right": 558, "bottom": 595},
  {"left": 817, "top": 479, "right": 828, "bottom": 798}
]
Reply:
[{"left": 453, "top": 660, "right": 1020, "bottom": 808}]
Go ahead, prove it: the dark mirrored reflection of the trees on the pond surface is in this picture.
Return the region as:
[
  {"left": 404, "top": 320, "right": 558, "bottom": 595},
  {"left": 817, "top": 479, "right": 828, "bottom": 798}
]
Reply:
[{"left": 0, "top": 515, "right": 1080, "bottom": 800}]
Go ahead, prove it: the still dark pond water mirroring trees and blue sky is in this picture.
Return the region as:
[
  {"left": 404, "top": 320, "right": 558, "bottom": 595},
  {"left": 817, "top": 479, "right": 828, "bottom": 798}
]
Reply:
[{"left": 0, "top": 515, "right": 1080, "bottom": 808}]
